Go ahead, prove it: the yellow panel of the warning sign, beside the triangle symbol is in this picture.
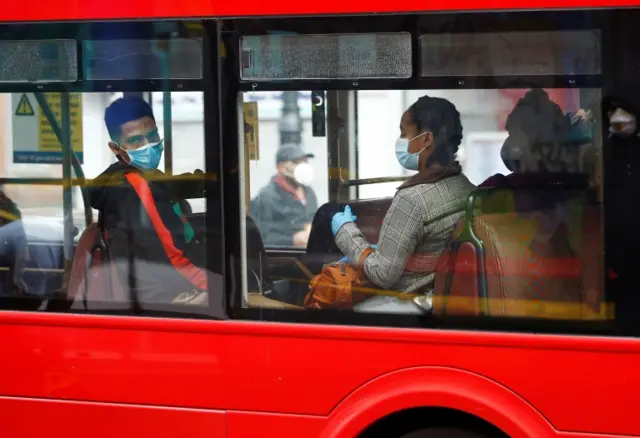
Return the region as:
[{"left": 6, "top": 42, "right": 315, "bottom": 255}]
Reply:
[{"left": 37, "top": 93, "right": 82, "bottom": 153}]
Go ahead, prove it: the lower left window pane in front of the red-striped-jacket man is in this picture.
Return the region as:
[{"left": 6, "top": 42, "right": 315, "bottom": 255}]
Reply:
[{"left": 0, "top": 93, "right": 215, "bottom": 313}]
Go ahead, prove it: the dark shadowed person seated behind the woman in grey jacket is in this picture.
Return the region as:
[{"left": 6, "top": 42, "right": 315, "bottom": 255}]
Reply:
[{"left": 480, "top": 89, "right": 604, "bottom": 311}]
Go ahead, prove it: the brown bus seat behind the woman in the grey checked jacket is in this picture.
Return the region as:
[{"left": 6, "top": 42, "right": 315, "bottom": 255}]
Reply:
[{"left": 434, "top": 186, "right": 602, "bottom": 319}]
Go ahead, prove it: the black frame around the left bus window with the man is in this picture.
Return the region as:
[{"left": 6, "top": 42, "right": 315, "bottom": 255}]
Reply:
[{"left": 0, "top": 20, "right": 228, "bottom": 319}]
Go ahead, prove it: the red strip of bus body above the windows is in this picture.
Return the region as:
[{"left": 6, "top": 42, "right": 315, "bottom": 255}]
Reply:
[{"left": 0, "top": 0, "right": 636, "bottom": 22}]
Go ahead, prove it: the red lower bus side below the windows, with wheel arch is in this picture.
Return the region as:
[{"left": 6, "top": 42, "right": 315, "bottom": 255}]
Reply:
[{"left": 0, "top": 312, "right": 640, "bottom": 438}]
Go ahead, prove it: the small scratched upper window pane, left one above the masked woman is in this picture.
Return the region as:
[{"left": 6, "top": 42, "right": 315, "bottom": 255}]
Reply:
[{"left": 240, "top": 33, "right": 412, "bottom": 80}]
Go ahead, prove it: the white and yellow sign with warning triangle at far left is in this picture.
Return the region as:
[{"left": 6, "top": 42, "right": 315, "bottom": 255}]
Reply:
[{"left": 11, "top": 93, "right": 83, "bottom": 164}]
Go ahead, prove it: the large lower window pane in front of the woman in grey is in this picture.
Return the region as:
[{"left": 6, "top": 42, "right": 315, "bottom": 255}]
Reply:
[{"left": 245, "top": 89, "right": 611, "bottom": 319}]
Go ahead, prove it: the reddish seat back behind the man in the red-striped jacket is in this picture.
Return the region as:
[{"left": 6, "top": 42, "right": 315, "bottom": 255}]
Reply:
[{"left": 67, "top": 223, "right": 125, "bottom": 307}]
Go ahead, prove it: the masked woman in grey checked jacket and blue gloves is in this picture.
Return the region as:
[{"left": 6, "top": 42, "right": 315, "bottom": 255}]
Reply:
[{"left": 331, "top": 96, "right": 475, "bottom": 313}]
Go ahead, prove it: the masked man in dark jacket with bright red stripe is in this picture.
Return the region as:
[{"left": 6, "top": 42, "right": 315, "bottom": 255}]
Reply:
[{"left": 89, "top": 97, "right": 207, "bottom": 302}]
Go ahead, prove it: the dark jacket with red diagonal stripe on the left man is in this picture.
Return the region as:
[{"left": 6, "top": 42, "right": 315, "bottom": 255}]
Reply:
[{"left": 89, "top": 163, "right": 207, "bottom": 302}]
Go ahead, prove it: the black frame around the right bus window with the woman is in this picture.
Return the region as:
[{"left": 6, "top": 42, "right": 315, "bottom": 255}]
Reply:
[{"left": 222, "top": 10, "right": 623, "bottom": 336}]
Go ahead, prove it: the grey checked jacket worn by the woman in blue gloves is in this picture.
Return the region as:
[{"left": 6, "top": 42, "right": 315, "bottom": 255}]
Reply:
[{"left": 336, "top": 173, "right": 475, "bottom": 293}]
